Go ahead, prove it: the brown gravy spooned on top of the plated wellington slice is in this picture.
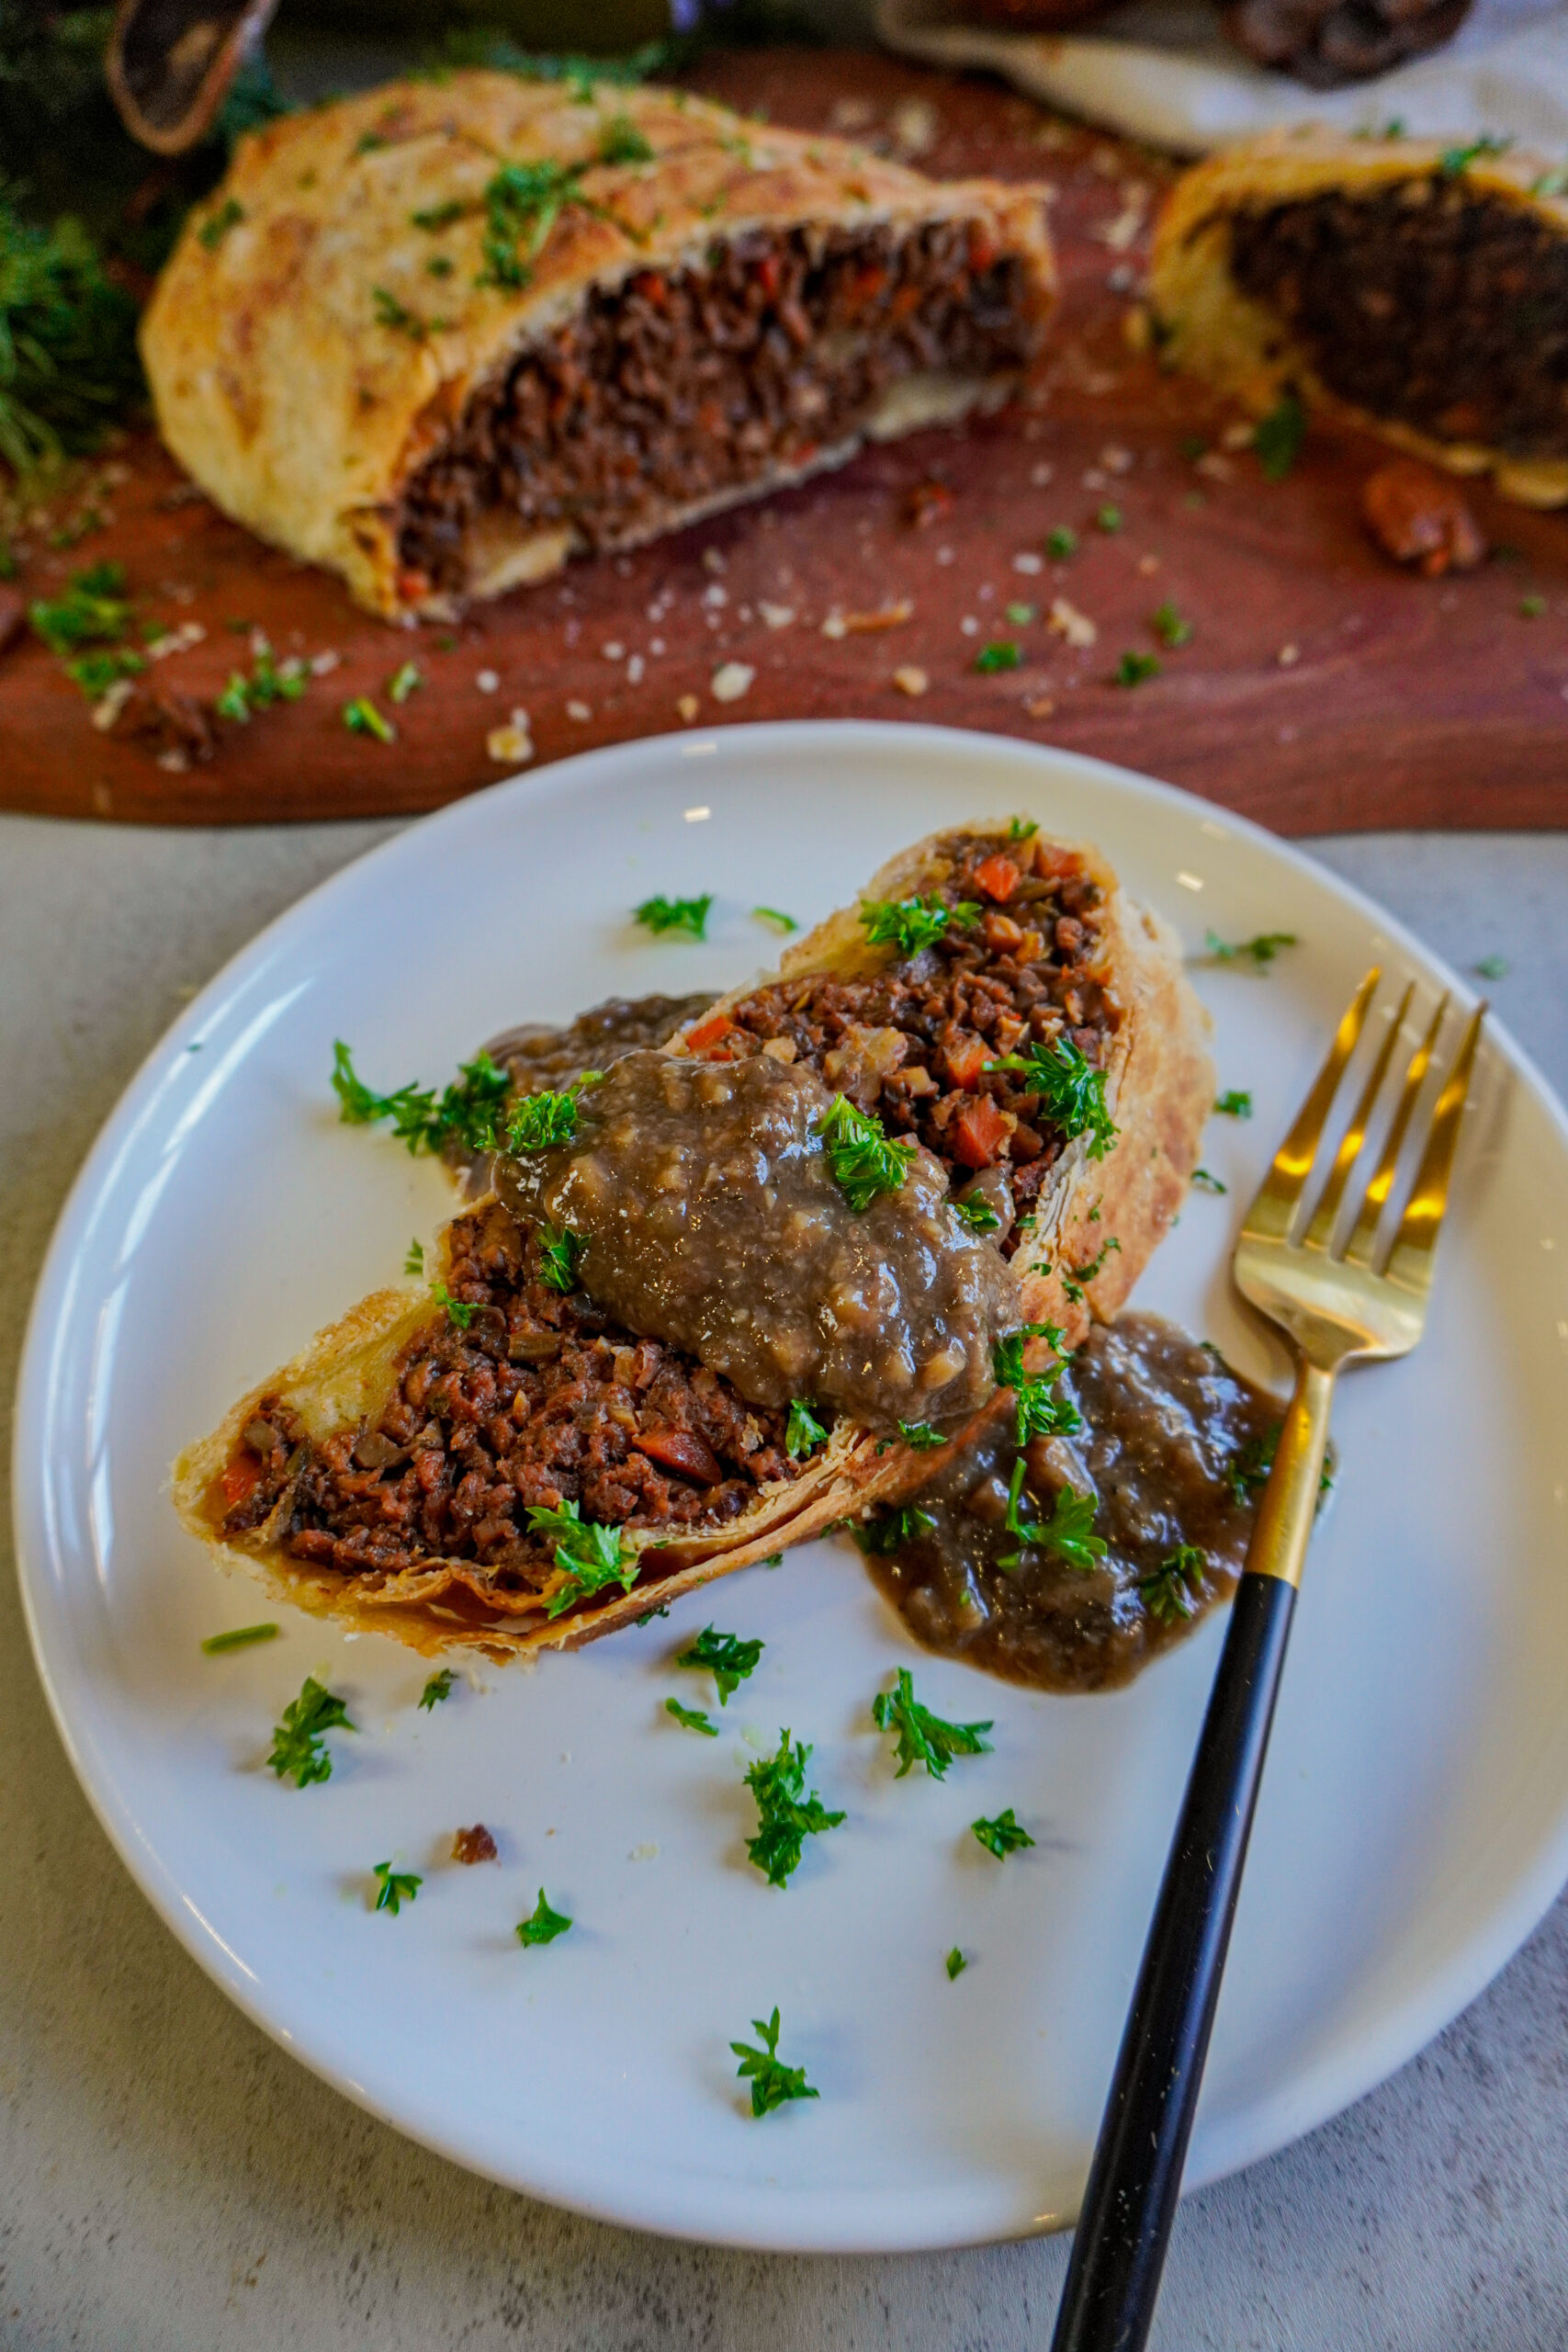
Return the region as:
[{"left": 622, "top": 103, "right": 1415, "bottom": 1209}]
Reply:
[{"left": 496, "top": 1051, "right": 1021, "bottom": 1435}]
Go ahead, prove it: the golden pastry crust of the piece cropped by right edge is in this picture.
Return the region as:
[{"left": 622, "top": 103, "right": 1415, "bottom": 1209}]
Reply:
[{"left": 1149, "top": 131, "right": 1568, "bottom": 505}]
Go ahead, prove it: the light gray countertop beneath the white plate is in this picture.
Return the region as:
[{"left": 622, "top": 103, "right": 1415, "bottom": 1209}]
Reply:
[{"left": 0, "top": 819, "right": 1568, "bottom": 2352}]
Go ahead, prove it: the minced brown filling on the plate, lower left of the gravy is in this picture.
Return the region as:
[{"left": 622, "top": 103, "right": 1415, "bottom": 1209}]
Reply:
[{"left": 223, "top": 1204, "right": 802, "bottom": 1592}]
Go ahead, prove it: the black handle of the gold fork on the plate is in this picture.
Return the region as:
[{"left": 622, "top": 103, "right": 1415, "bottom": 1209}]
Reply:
[{"left": 1051, "top": 1574, "right": 1295, "bottom": 2352}]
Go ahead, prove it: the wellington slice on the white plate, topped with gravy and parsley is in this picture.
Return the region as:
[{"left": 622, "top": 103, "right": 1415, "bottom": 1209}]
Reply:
[{"left": 174, "top": 820, "right": 1213, "bottom": 1656}]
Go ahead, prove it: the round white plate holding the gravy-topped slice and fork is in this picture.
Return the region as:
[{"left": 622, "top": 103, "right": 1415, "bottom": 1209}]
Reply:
[{"left": 17, "top": 727, "right": 1568, "bottom": 2248}]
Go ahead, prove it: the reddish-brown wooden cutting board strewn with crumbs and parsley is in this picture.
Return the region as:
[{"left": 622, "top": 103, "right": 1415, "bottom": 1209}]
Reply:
[{"left": 0, "top": 50, "right": 1568, "bottom": 832}]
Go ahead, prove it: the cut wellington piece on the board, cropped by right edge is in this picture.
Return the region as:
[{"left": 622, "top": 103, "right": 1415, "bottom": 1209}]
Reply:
[{"left": 1149, "top": 134, "right": 1568, "bottom": 505}]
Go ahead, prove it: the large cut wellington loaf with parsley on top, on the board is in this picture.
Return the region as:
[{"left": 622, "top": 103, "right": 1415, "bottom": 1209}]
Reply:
[{"left": 141, "top": 73, "right": 1055, "bottom": 618}]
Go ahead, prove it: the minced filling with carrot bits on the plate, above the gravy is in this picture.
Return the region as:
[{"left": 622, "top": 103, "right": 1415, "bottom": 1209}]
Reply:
[{"left": 686, "top": 832, "right": 1119, "bottom": 1259}]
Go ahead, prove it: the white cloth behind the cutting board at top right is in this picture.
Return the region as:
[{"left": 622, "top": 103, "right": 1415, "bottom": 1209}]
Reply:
[{"left": 877, "top": 0, "right": 1568, "bottom": 160}]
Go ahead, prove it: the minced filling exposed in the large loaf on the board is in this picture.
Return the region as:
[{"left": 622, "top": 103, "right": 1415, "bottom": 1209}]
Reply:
[{"left": 400, "top": 221, "right": 1042, "bottom": 591}]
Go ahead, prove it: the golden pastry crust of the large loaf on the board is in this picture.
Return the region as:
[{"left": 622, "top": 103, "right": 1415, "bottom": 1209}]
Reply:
[{"left": 141, "top": 73, "right": 1055, "bottom": 616}]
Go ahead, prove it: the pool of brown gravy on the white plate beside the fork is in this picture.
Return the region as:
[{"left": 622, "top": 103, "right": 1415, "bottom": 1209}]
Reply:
[{"left": 867, "top": 1315, "right": 1283, "bottom": 1691}]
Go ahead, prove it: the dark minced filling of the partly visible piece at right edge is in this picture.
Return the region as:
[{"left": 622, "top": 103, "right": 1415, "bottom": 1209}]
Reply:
[{"left": 1229, "top": 174, "right": 1568, "bottom": 458}]
